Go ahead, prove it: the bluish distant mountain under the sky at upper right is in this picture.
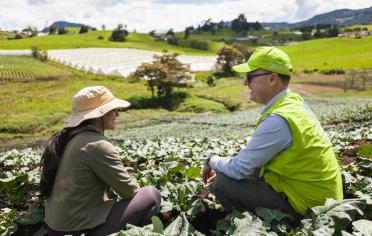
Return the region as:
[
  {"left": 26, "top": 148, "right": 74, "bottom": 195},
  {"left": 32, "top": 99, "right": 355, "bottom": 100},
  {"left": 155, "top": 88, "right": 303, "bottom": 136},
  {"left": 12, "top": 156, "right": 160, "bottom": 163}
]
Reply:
[{"left": 262, "top": 7, "right": 372, "bottom": 30}]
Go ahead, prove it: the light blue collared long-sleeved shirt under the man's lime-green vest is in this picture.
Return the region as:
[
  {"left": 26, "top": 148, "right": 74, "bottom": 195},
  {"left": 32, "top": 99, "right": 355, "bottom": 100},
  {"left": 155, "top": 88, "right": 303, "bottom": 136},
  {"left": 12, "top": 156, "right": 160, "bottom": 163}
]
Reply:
[{"left": 209, "top": 89, "right": 292, "bottom": 180}]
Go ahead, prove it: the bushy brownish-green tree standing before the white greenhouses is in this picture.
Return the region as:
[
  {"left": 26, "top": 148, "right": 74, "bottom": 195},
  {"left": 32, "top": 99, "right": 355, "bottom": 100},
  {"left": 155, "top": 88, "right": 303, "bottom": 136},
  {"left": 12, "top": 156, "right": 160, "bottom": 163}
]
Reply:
[{"left": 134, "top": 53, "right": 191, "bottom": 98}]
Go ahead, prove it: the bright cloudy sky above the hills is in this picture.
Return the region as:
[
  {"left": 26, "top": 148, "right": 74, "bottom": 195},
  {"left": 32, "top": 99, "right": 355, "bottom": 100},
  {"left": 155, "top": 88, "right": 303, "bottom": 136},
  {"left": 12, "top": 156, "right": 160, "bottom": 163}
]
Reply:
[{"left": 0, "top": 0, "right": 372, "bottom": 32}]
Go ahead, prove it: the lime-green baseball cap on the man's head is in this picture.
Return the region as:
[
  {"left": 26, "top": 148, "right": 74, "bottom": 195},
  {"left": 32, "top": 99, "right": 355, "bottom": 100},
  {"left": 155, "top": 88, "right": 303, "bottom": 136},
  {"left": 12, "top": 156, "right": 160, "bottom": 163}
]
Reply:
[{"left": 232, "top": 47, "right": 292, "bottom": 75}]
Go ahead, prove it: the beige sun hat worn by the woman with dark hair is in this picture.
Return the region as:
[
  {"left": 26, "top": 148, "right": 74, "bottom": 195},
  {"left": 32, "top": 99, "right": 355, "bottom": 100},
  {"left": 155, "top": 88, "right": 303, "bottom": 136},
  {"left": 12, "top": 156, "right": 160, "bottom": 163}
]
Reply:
[{"left": 65, "top": 86, "right": 130, "bottom": 128}]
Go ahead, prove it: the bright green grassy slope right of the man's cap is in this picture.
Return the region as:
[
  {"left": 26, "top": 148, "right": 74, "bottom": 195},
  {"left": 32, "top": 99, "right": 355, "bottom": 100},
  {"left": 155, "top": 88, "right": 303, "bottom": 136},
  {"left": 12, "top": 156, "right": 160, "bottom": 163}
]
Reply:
[{"left": 279, "top": 37, "right": 372, "bottom": 71}]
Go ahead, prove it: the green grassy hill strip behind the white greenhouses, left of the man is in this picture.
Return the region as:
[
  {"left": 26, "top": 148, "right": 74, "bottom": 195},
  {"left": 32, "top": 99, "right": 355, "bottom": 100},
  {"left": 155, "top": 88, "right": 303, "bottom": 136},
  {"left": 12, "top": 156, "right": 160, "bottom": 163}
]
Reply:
[{"left": 0, "top": 28, "right": 223, "bottom": 55}]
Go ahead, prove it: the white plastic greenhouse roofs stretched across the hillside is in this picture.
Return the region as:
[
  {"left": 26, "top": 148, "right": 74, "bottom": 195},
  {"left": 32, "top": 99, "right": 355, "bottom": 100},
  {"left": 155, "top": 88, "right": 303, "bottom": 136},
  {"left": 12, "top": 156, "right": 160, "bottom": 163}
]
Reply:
[{"left": 0, "top": 48, "right": 217, "bottom": 76}]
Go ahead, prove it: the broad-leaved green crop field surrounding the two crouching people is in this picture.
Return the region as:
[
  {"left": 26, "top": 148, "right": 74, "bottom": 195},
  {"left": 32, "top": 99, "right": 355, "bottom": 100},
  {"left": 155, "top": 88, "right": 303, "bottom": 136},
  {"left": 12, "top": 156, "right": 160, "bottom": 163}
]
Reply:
[{"left": 0, "top": 101, "right": 372, "bottom": 235}]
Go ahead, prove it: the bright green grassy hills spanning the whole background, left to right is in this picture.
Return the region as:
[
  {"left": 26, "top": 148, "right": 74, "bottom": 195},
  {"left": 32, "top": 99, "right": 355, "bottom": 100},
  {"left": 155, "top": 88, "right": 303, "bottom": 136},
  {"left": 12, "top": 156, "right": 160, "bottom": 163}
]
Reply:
[{"left": 0, "top": 26, "right": 372, "bottom": 72}]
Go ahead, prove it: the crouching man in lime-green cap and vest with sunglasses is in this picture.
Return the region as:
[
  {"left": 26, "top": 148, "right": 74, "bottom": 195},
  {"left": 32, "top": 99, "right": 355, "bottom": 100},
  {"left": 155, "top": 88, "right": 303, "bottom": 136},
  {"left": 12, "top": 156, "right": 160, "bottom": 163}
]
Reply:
[{"left": 202, "top": 47, "right": 343, "bottom": 220}]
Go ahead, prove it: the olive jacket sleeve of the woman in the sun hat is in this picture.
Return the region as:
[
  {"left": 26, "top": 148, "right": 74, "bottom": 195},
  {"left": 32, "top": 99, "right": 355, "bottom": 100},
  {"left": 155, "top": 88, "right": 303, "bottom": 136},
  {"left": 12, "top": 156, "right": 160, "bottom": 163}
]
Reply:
[{"left": 87, "top": 140, "right": 139, "bottom": 198}]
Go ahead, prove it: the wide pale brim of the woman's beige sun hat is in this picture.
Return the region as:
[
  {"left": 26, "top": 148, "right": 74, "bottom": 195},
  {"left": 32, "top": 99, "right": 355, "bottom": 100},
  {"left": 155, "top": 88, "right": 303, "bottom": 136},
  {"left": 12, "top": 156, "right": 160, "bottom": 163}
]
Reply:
[{"left": 65, "top": 98, "right": 130, "bottom": 128}]
